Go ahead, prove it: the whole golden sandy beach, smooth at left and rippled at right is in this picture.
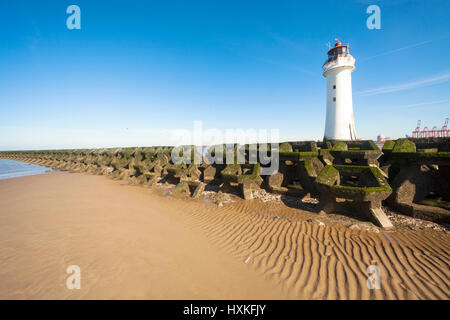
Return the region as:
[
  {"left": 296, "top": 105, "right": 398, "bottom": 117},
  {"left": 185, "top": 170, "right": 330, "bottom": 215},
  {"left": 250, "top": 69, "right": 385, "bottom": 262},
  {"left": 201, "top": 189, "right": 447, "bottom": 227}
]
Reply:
[{"left": 0, "top": 173, "right": 450, "bottom": 299}]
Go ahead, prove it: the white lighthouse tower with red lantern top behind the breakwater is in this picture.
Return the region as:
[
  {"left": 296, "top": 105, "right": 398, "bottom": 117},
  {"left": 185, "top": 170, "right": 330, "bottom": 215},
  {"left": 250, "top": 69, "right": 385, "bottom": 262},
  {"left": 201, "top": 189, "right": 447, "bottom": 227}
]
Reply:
[{"left": 322, "top": 39, "right": 356, "bottom": 140}]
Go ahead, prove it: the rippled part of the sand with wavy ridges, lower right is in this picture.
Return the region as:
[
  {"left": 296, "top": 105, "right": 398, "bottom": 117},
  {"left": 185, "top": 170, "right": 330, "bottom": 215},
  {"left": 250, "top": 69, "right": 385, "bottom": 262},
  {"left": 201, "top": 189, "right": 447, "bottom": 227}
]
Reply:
[{"left": 173, "top": 201, "right": 450, "bottom": 299}]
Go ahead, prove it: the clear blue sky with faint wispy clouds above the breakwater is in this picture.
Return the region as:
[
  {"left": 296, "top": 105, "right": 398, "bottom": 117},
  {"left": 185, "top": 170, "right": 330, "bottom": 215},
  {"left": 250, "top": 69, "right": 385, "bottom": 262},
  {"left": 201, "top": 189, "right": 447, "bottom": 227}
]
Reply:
[{"left": 0, "top": 0, "right": 450, "bottom": 150}]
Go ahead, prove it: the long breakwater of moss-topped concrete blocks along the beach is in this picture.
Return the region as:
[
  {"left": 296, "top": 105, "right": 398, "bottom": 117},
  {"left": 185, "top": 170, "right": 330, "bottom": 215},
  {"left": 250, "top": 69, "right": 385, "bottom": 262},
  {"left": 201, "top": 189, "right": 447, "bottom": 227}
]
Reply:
[{"left": 0, "top": 138, "right": 450, "bottom": 229}]
